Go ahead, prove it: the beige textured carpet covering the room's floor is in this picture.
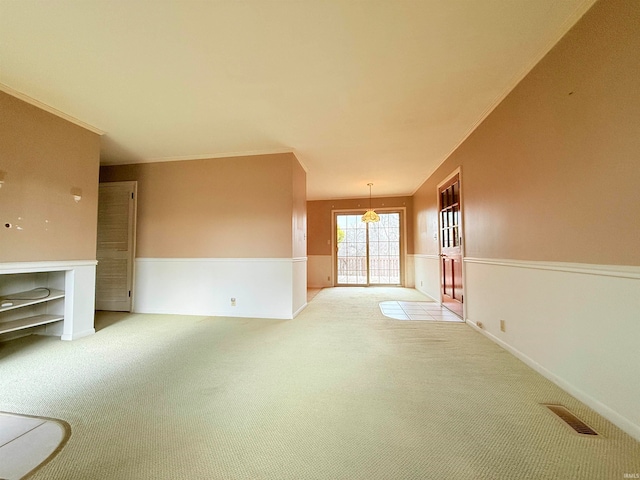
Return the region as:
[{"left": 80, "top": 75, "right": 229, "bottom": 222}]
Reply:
[{"left": 0, "top": 288, "right": 640, "bottom": 480}]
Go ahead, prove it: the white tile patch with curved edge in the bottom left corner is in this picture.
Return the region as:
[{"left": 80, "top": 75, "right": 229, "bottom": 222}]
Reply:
[{"left": 0, "top": 412, "right": 71, "bottom": 480}]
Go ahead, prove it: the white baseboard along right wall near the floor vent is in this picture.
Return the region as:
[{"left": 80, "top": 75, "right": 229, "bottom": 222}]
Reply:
[{"left": 466, "top": 319, "right": 640, "bottom": 439}]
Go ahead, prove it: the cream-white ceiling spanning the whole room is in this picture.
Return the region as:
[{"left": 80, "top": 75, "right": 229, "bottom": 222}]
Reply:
[{"left": 0, "top": 0, "right": 594, "bottom": 200}]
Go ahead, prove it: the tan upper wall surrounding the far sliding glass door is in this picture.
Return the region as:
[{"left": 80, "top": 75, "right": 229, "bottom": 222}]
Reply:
[{"left": 307, "top": 197, "right": 413, "bottom": 255}]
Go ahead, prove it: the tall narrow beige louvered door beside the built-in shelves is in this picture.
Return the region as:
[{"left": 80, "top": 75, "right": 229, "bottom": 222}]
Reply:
[{"left": 96, "top": 182, "right": 137, "bottom": 312}]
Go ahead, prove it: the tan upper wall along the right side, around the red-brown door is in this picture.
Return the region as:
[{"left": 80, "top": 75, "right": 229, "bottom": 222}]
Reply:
[{"left": 414, "top": 0, "right": 640, "bottom": 265}]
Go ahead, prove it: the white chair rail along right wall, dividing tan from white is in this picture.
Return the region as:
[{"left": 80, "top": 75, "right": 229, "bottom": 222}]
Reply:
[{"left": 463, "top": 257, "right": 640, "bottom": 280}]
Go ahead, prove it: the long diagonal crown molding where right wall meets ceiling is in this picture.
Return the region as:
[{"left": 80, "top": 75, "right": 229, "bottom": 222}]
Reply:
[{"left": 409, "top": 0, "right": 596, "bottom": 197}]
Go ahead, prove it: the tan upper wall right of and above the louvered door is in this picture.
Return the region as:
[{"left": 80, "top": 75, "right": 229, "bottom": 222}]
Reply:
[{"left": 100, "top": 153, "right": 305, "bottom": 258}]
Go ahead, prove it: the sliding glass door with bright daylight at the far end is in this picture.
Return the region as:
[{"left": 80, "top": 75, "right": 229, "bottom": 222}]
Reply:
[{"left": 334, "top": 211, "right": 402, "bottom": 286}]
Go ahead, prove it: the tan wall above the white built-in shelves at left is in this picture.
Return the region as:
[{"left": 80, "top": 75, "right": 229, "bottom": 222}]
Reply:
[{"left": 0, "top": 91, "right": 100, "bottom": 262}]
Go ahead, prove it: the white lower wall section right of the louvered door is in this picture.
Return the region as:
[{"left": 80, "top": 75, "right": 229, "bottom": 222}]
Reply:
[{"left": 133, "top": 258, "right": 306, "bottom": 319}]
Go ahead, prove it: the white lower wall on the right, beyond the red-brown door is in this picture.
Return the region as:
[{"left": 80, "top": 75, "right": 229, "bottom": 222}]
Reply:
[{"left": 462, "top": 258, "right": 640, "bottom": 440}]
